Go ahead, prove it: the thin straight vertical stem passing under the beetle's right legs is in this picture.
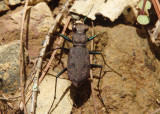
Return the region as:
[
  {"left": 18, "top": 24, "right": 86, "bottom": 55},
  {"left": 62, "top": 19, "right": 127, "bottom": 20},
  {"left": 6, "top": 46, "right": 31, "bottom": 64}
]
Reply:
[{"left": 90, "top": 22, "right": 97, "bottom": 114}]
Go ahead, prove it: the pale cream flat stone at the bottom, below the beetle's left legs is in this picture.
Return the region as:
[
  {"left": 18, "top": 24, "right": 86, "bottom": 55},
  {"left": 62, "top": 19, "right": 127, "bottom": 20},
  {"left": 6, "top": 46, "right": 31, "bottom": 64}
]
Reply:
[{"left": 27, "top": 73, "right": 73, "bottom": 114}]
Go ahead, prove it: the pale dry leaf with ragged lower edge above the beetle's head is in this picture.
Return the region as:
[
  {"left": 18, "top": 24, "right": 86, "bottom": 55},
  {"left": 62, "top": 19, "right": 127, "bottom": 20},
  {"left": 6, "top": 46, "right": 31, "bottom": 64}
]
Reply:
[{"left": 70, "top": 0, "right": 138, "bottom": 21}]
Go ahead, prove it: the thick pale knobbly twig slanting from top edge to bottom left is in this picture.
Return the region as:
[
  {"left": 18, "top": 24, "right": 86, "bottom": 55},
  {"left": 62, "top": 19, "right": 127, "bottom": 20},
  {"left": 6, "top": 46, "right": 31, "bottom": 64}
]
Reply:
[{"left": 31, "top": 1, "right": 72, "bottom": 114}]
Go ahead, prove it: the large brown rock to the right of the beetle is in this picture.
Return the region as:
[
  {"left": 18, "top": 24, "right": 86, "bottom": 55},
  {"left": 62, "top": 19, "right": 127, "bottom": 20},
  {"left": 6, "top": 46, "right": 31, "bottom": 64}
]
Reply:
[{"left": 101, "top": 25, "right": 160, "bottom": 114}]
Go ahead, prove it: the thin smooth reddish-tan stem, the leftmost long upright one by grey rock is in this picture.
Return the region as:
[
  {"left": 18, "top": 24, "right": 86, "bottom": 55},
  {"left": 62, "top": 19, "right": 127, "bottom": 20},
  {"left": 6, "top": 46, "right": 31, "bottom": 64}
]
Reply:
[{"left": 20, "top": 0, "right": 28, "bottom": 114}]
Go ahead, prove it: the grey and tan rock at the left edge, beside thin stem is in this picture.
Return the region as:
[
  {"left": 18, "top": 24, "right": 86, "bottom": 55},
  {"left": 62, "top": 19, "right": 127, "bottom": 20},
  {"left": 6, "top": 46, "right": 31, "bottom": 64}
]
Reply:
[{"left": 0, "top": 40, "right": 20, "bottom": 94}]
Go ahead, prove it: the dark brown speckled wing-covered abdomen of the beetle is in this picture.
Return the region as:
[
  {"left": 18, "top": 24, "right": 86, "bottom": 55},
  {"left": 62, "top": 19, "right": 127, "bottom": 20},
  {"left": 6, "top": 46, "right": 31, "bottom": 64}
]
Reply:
[{"left": 67, "top": 46, "right": 90, "bottom": 86}]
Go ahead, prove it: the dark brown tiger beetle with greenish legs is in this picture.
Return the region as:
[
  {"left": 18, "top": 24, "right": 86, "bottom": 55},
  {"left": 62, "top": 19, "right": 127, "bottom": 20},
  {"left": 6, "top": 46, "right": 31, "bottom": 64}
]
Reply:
[{"left": 55, "top": 21, "right": 102, "bottom": 96}]
